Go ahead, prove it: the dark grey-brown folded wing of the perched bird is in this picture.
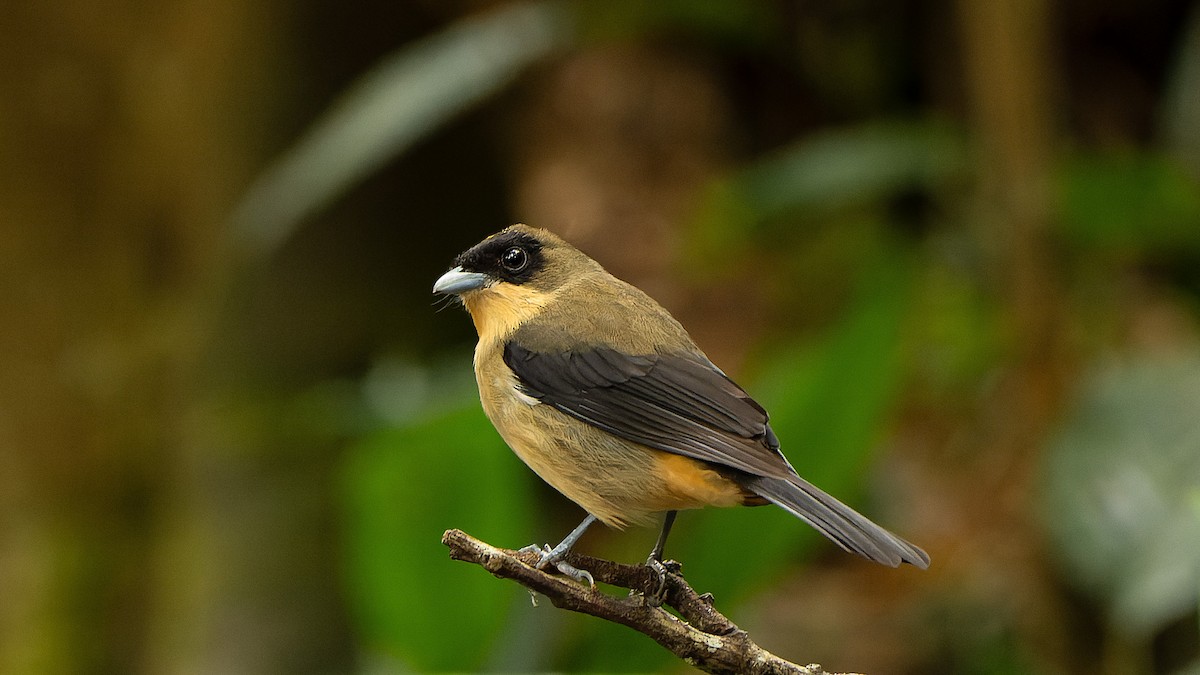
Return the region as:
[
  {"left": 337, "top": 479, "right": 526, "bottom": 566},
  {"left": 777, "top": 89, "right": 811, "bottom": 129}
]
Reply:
[{"left": 504, "top": 340, "right": 794, "bottom": 478}]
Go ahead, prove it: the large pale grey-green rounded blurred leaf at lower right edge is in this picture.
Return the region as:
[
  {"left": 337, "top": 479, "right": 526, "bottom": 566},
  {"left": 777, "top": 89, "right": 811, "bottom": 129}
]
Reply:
[{"left": 1043, "top": 357, "right": 1200, "bottom": 637}]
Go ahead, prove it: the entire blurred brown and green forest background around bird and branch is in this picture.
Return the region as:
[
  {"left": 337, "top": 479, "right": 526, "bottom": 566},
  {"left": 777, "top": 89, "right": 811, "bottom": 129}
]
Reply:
[{"left": 0, "top": 0, "right": 1200, "bottom": 674}]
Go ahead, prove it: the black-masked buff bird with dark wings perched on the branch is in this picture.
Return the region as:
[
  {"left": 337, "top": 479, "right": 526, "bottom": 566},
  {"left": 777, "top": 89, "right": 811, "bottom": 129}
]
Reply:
[{"left": 433, "top": 225, "right": 929, "bottom": 583}]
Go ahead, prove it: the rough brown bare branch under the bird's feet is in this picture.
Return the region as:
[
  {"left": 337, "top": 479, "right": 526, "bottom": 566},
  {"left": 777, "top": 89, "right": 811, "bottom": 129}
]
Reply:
[{"left": 442, "top": 530, "right": 854, "bottom": 675}]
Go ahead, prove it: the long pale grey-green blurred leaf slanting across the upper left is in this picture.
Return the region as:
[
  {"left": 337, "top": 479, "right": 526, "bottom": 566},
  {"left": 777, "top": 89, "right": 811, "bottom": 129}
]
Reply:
[{"left": 232, "top": 2, "right": 574, "bottom": 256}]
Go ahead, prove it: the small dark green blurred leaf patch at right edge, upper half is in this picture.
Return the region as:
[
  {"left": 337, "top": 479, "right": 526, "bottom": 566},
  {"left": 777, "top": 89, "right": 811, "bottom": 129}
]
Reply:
[{"left": 1060, "top": 154, "right": 1200, "bottom": 251}]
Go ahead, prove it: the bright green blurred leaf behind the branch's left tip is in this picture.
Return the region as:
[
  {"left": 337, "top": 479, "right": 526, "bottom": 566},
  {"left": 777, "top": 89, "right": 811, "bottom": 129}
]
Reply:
[{"left": 342, "top": 404, "right": 533, "bottom": 671}]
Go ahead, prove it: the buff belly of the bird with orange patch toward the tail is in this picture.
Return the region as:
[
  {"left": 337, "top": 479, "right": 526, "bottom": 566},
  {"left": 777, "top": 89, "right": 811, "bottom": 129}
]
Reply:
[{"left": 480, "top": 362, "right": 744, "bottom": 527}]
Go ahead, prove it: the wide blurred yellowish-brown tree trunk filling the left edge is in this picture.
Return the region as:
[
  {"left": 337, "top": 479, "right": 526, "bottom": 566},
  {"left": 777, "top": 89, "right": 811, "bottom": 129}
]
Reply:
[{"left": 0, "top": 0, "right": 350, "bottom": 673}]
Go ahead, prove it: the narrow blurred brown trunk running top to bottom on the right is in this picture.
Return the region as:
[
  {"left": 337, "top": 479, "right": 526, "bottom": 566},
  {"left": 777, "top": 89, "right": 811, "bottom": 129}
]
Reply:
[{"left": 958, "top": 0, "right": 1069, "bottom": 671}]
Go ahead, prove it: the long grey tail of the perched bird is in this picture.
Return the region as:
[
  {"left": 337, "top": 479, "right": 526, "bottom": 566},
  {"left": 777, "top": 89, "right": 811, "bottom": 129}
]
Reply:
[{"left": 742, "top": 476, "right": 929, "bottom": 569}]
